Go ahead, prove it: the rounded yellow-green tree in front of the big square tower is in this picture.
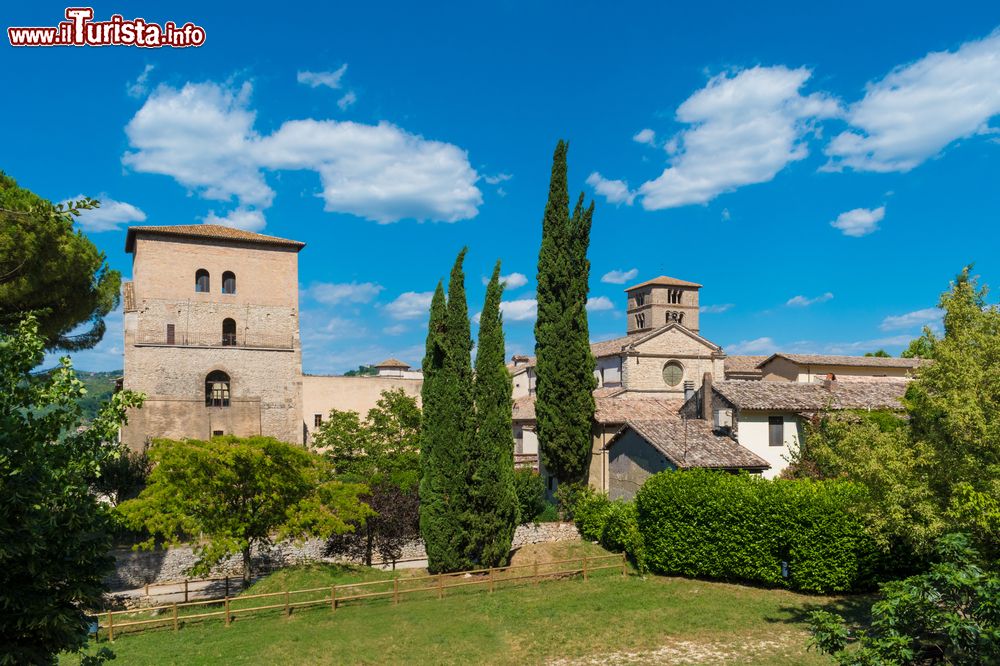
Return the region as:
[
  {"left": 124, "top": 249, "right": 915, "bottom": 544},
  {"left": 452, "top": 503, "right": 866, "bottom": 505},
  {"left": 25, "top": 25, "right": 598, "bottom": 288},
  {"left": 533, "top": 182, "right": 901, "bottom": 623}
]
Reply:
[{"left": 118, "top": 436, "right": 372, "bottom": 581}]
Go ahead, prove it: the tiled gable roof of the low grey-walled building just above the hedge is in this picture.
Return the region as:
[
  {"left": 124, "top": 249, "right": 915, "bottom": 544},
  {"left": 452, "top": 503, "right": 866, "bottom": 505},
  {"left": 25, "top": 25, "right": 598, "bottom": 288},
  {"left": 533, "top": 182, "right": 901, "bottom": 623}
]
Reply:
[{"left": 605, "top": 418, "right": 771, "bottom": 470}]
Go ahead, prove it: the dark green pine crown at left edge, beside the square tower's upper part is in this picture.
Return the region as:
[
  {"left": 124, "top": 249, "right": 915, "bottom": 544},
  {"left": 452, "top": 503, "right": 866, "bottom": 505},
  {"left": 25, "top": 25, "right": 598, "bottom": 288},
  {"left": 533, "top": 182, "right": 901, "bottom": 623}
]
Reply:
[{"left": 0, "top": 172, "right": 121, "bottom": 350}]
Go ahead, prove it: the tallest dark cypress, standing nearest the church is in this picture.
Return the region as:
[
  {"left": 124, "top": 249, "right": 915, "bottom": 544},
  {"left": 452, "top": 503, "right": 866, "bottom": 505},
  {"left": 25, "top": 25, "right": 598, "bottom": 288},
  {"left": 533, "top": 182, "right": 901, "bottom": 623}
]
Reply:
[{"left": 535, "top": 140, "right": 597, "bottom": 482}]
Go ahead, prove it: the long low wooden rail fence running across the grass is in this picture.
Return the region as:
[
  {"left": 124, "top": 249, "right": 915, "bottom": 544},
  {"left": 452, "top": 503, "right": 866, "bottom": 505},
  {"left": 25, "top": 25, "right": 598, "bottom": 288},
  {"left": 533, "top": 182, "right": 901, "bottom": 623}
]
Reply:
[{"left": 98, "top": 554, "right": 628, "bottom": 641}]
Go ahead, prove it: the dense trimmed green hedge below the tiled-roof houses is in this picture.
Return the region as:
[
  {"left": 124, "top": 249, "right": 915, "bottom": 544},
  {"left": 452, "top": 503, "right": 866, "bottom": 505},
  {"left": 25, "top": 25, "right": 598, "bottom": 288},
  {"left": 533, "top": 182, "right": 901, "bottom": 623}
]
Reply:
[{"left": 636, "top": 470, "right": 879, "bottom": 593}]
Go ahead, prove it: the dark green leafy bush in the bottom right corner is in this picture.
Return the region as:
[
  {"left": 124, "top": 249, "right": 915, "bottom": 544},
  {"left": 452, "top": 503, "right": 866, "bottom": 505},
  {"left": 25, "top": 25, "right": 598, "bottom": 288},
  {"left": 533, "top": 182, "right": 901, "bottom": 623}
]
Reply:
[{"left": 809, "top": 534, "right": 1000, "bottom": 666}]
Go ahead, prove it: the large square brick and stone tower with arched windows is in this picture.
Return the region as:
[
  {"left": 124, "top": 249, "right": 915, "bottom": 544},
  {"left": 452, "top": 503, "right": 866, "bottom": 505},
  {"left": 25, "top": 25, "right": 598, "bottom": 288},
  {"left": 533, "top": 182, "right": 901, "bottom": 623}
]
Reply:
[{"left": 122, "top": 224, "right": 304, "bottom": 448}]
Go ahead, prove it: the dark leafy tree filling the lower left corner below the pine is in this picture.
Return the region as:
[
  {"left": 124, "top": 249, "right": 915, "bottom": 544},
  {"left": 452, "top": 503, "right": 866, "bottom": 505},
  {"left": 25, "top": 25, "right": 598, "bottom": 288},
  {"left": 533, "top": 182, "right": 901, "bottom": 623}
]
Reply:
[{"left": 0, "top": 316, "right": 141, "bottom": 664}]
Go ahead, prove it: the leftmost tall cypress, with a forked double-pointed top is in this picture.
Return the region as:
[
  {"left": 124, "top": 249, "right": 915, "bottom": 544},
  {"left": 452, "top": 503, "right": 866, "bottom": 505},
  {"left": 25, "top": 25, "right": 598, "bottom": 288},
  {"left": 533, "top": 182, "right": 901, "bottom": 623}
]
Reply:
[{"left": 420, "top": 248, "right": 475, "bottom": 573}]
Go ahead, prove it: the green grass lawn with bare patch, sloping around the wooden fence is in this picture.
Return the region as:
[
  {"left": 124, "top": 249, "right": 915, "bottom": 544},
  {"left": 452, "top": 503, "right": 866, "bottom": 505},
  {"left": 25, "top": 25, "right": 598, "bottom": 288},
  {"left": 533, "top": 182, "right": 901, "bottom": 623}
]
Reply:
[{"left": 61, "top": 542, "right": 870, "bottom": 665}]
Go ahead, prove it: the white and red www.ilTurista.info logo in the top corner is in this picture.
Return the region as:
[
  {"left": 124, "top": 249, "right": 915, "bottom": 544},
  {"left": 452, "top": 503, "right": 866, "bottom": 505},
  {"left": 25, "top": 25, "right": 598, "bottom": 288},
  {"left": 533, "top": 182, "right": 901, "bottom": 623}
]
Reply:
[{"left": 7, "top": 7, "right": 205, "bottom": 49}]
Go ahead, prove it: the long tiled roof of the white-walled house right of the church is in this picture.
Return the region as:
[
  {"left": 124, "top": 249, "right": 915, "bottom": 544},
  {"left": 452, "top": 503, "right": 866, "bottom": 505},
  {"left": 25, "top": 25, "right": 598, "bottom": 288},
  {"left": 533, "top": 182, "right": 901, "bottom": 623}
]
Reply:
[{"left": 712, "top": 380, "right": 909, "bottom": 412}]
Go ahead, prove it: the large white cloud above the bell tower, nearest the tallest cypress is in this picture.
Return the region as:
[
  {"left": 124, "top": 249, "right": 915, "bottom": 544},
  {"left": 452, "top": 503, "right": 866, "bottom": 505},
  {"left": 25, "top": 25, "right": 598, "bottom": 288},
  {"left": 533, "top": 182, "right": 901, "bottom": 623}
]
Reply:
[{"left": 639, "top": 66, "right": 839, "bottom": 210}]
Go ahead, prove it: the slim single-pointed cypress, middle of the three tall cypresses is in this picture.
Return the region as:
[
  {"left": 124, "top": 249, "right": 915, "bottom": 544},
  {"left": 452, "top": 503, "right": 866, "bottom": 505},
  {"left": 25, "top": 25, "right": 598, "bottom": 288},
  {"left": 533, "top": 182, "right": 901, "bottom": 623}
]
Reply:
[{"left": 469, "top": 261, "right": 518, "bottom": 567}]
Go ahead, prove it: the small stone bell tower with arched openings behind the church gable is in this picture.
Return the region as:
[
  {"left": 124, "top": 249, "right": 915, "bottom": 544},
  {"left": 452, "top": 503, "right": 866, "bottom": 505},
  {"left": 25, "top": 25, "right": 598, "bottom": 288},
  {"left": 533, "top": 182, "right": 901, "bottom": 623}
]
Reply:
[{"left": 625, "top": 275, "right": 701, "bottom": 335}]
